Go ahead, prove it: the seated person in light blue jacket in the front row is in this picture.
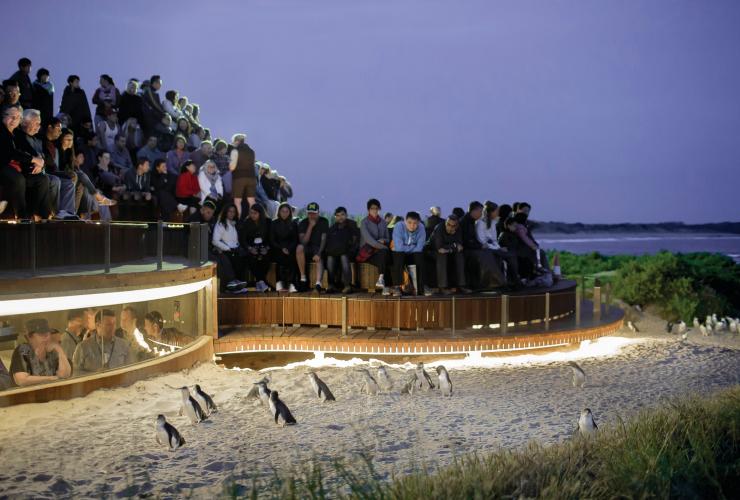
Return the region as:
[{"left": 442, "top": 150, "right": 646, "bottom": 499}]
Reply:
[{"left": 393, "top": 212, "right": 432, "bottom": 296}]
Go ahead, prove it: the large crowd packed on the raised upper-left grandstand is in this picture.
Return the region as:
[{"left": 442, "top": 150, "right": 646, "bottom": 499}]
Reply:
[{"left": 0, "top": 57, "right": 293, "bottom": 221}]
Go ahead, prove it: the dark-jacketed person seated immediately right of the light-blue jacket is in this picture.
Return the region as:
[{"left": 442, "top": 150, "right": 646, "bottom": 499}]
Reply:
[{"left": 427, "top": 215, "right": 471, "bottom": 295}]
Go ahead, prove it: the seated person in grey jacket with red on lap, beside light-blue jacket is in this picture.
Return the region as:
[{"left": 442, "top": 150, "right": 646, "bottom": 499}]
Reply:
[{"left": 355, "top": 198, "right": 393, "bottom": 295}]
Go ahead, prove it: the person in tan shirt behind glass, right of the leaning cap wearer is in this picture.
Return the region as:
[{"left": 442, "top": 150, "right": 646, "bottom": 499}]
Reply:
[{"left": 72, "top": 309, "right": 132, "bottom": 375}]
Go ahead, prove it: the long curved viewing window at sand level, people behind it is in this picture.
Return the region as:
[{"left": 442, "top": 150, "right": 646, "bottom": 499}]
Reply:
[{"left": 0, "top": 292, "right": 199, "bottom": 390}]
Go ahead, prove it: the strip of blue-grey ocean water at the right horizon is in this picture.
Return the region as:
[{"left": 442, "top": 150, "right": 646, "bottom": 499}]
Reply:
[{"left": 535, "top": 233, "right": 740, "bottom": 263}]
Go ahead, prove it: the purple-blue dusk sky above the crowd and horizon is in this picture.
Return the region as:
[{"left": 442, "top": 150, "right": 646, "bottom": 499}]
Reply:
[{"left": 0, "top": 0, "right": 740, "bottom": 222}]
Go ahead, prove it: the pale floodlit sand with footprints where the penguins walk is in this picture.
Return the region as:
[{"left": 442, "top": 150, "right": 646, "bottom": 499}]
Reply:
[{"left": 0, "top": 315, "right": 740, "bottom": 498}]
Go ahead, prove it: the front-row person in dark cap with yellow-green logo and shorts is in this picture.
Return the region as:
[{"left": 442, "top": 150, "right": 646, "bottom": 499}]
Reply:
[{"left": 296, "top": 202, "right": 329, "bottom": 292}]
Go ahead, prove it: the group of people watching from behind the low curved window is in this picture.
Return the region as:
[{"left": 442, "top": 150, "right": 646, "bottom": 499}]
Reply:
[{"left": 0, "top": 306, "right": 192, "bottom": 390}]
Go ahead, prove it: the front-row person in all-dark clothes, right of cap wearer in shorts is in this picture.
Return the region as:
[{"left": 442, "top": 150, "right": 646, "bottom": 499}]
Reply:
[{"left": 326, "top": 207, "right": 360, "bottom": 294}]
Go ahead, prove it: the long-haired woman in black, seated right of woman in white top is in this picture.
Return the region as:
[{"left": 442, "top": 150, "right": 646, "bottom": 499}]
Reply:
[{"left": 238, "top": 203, "right": 271, "bottom": 292}]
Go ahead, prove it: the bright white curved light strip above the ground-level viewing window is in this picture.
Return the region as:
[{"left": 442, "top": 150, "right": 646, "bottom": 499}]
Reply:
[{"left": 0, "top": 278, "right": 211, "bottom": 316}]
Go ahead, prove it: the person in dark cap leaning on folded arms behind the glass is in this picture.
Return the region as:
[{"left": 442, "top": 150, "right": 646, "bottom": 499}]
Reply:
[{"left": 10, "top": 318, "right": 72, "bottom": 387}]
